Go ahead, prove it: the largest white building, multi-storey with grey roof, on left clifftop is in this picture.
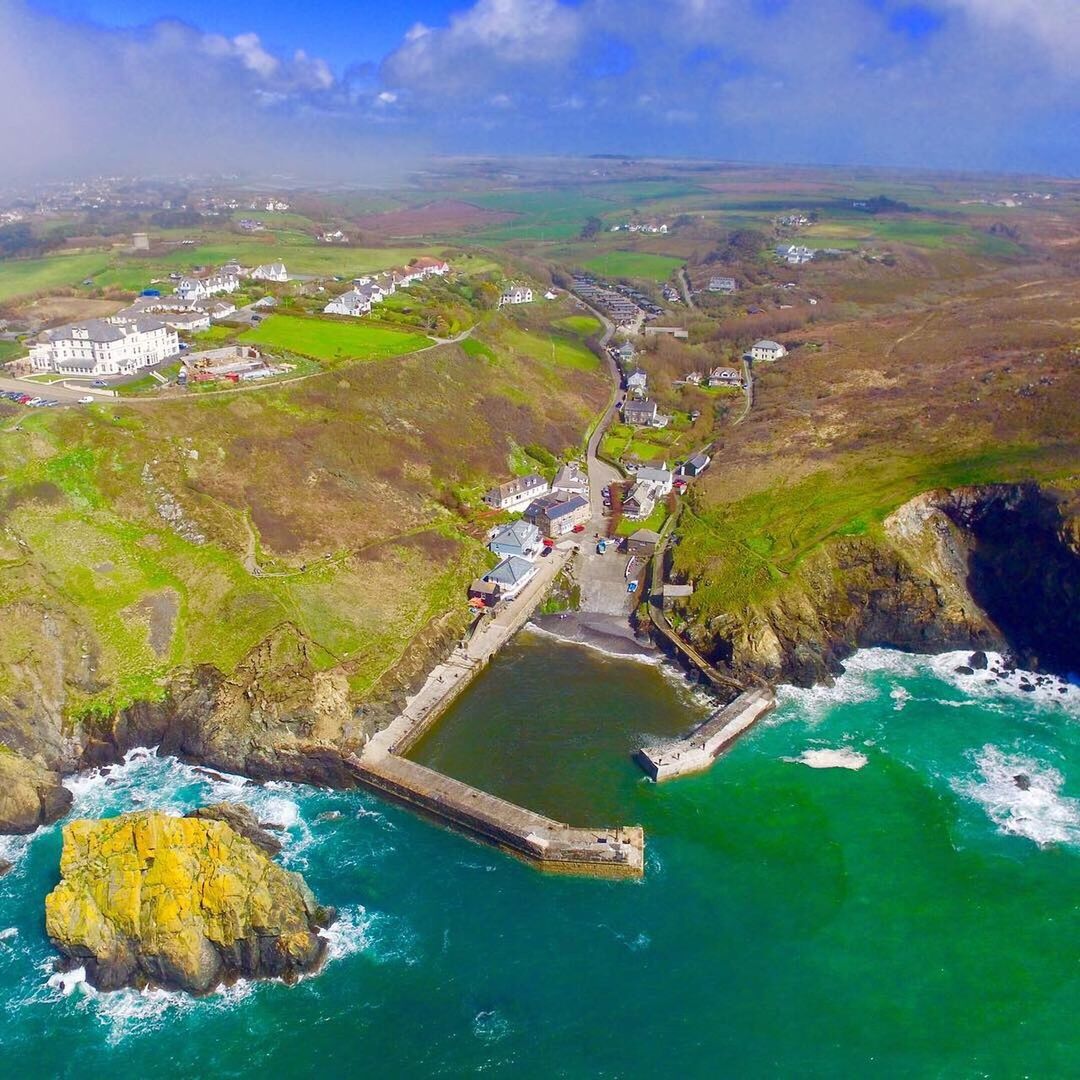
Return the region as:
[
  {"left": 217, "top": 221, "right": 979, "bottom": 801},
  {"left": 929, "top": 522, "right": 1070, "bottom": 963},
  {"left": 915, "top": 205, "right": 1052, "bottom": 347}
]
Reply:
[{"left": 30, "top": 315, "right": 180, "bottom": 378}]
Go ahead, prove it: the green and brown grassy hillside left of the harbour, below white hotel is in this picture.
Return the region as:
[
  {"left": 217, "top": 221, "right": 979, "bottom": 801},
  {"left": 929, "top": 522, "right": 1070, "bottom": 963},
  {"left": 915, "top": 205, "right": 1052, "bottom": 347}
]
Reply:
[{"left": 0, "top": 308, "right": 607, "bottom": 713}]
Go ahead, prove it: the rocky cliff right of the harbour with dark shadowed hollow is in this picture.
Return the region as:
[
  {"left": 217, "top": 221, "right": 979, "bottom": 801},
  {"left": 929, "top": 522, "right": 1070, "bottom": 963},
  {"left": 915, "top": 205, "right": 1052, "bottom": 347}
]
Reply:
[{"left": 691, "top": 484, "right": 1080, "bottom": 686}]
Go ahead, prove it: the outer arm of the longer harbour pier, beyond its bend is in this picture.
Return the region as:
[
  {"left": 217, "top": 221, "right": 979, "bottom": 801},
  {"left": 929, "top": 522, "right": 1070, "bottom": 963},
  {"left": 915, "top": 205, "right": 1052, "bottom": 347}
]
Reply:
[{"left": 348, "top": 754, "right": 645, "bottom": 878}]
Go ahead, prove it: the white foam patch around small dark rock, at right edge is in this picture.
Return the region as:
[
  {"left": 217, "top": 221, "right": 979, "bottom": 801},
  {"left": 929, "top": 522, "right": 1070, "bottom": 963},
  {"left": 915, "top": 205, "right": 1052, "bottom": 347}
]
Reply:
[{"left": 953, "top": 745, "right": 1080, "bottom": 846}]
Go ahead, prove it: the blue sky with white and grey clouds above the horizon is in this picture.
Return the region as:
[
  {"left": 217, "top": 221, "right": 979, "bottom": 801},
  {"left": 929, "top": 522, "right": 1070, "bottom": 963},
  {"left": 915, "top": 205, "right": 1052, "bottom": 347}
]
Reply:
[{"left": 0, "top": 0, "right": 1080, "bottom": 183}]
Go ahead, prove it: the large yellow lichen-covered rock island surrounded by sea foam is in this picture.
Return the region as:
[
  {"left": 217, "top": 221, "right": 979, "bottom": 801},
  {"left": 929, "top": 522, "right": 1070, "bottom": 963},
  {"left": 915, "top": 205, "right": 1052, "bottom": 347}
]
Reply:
[{"left": 45, "top": 811, "right": 329, "bottom": 994}]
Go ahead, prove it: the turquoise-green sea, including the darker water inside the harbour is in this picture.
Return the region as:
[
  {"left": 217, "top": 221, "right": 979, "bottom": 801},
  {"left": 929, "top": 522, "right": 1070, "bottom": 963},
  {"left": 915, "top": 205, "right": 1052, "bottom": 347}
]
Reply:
[{"left": 0, "top": 634, "right": 1080, "bottom": 1080}]
